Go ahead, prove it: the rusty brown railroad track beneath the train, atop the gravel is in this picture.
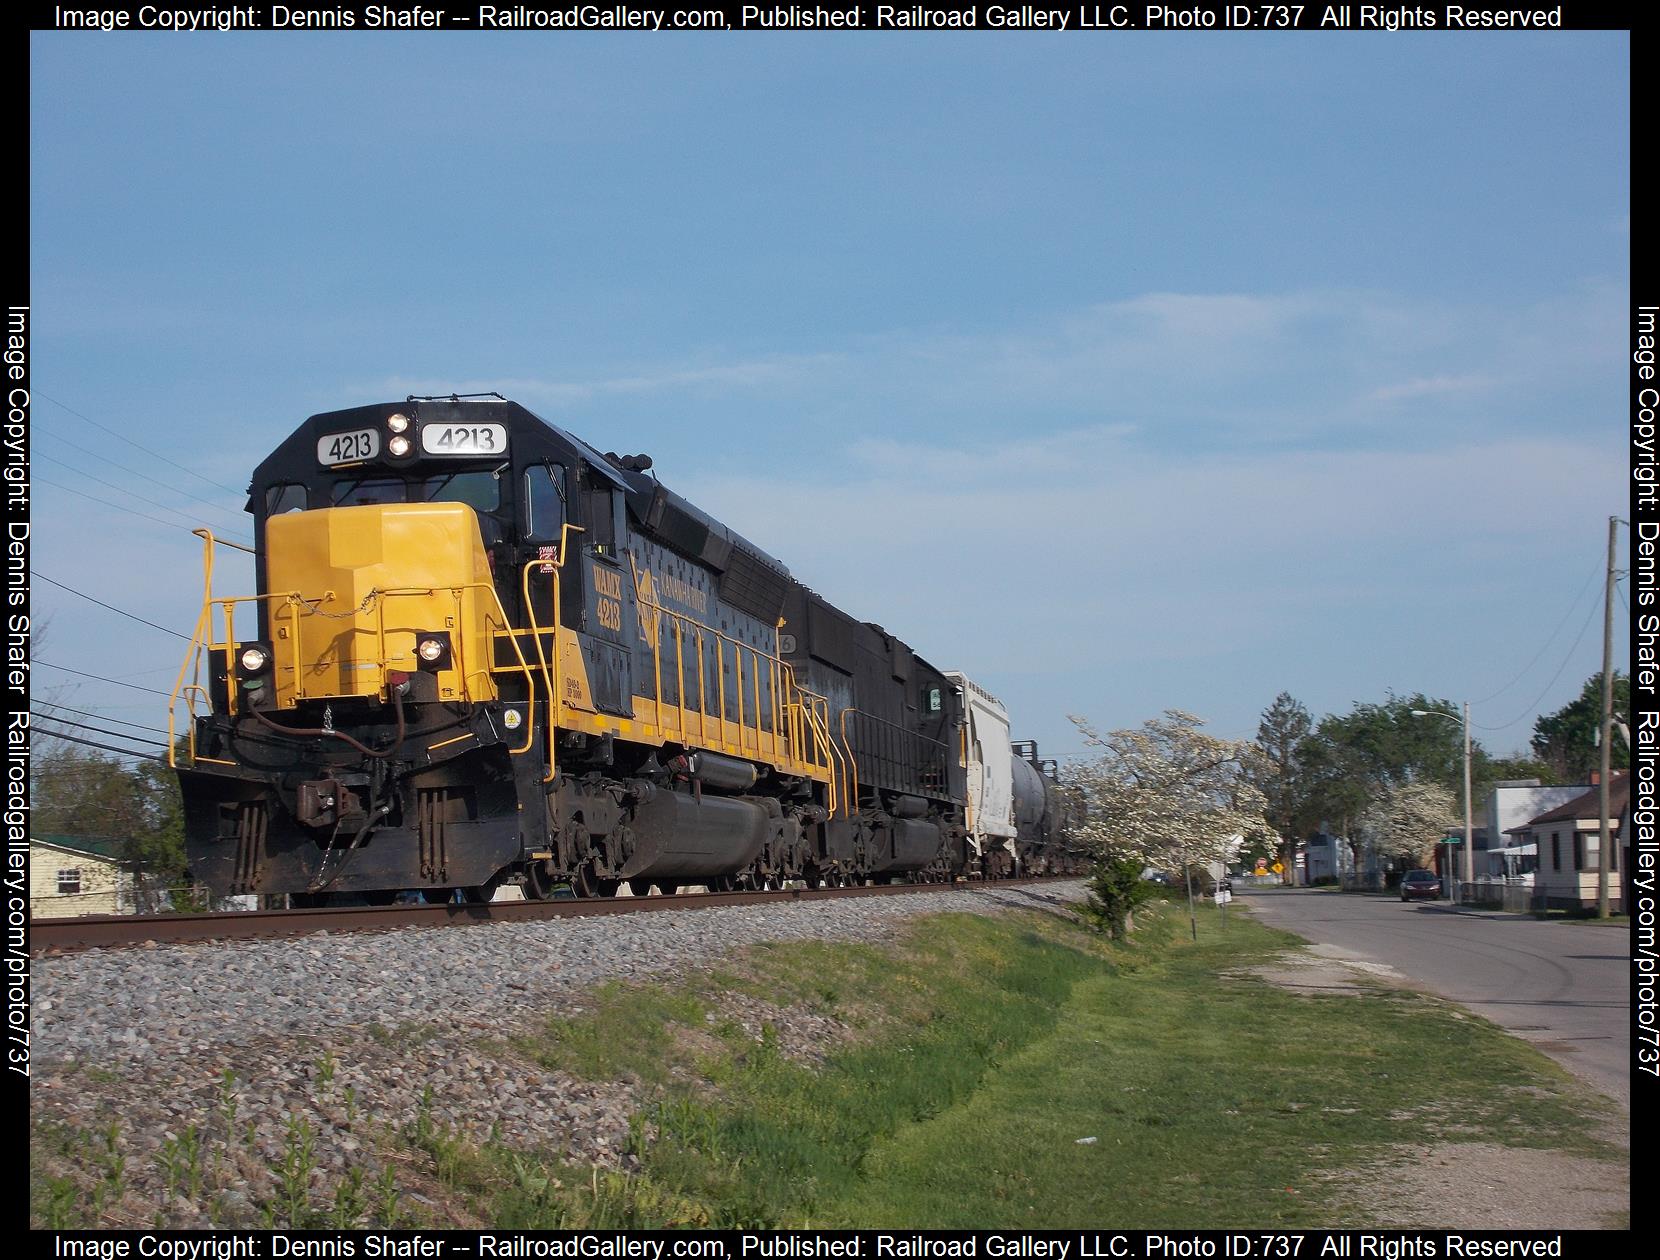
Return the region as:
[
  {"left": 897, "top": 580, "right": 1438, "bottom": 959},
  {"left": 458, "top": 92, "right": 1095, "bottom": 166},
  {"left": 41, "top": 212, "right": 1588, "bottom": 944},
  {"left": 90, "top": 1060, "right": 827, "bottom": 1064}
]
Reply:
[{"left": 28, "top": 875, "right": 1074, "bottom": 955}]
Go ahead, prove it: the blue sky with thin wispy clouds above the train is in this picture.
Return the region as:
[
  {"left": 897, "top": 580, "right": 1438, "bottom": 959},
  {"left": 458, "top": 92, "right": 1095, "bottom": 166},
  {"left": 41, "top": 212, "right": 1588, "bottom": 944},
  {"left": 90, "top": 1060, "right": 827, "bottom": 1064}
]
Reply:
[{"left": 30, "top": 32, "right": 1630, "bottom": 754}]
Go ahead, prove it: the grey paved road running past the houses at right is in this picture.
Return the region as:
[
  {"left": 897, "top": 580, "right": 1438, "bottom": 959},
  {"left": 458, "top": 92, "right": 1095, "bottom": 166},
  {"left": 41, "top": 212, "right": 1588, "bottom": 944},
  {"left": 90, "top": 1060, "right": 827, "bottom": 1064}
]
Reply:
[{"left": 1240, "top": 888, "right": 1632, "bottom": 1111}]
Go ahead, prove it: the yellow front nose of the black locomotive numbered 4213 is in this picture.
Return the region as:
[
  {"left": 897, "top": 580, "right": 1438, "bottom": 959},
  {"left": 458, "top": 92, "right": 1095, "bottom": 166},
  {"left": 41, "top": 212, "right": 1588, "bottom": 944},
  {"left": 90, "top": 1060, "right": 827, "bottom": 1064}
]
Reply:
[{"left": 266, "top": 503, "right": 505, "bottom": 709}]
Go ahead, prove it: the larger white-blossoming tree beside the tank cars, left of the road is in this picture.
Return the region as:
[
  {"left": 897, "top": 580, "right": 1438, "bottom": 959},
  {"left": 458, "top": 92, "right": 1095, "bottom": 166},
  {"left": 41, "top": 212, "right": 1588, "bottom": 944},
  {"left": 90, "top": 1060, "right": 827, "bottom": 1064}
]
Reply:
[{"left": 1072, "top": 709, "right": 1267, "bottom": 867}]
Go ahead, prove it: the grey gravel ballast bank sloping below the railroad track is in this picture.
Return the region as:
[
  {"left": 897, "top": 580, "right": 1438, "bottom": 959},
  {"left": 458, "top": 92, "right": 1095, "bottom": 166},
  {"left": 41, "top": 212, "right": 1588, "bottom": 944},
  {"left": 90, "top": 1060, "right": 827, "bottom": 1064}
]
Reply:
[{"left": 32, "top": 882, "right": 1082, "bottom": 1227}]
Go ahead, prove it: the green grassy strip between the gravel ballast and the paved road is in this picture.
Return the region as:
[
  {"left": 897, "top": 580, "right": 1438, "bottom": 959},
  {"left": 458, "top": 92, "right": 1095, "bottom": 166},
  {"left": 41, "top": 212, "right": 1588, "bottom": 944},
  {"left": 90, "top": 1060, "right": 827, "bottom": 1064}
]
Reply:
[{"left": 440, "top": 906, "right": 1612, "bottom": 1227}]
